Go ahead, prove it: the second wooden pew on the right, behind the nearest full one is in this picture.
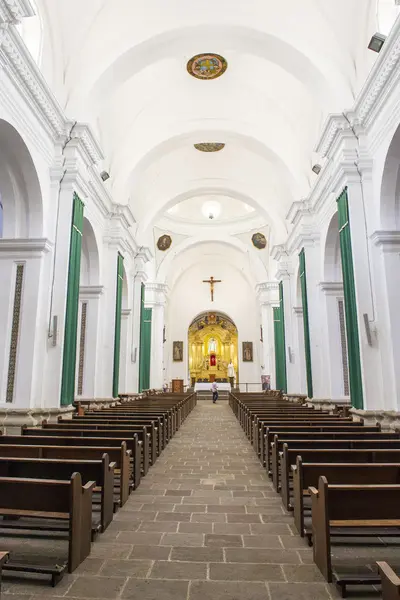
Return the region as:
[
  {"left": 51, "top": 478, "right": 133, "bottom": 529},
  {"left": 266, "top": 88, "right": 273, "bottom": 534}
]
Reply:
[{"left": 291, "top": 456, "right": 400, "bottom": 545}]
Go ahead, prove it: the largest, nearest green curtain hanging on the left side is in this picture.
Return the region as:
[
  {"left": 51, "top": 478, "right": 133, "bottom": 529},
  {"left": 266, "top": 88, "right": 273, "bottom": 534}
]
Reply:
[{"left": 61, "top": 193, "right": 84, "bottom": 406}]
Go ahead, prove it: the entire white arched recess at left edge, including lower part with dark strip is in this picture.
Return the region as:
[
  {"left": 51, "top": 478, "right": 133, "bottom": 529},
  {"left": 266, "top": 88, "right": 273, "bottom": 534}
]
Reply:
[{"left": 0, "top": 119, "right": 46, "bottom": 406}]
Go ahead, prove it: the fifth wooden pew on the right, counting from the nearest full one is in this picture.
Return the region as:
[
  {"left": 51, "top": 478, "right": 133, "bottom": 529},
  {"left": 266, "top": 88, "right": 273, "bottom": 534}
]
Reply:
[{"left": 260, "top": 422, "right": 381, "bottom": 475}]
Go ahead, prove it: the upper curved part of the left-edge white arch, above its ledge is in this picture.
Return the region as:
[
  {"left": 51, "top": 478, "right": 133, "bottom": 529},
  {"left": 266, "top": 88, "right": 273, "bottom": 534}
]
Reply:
[{"left": 0, "top": 119, "right": 43, "bottom": 239}]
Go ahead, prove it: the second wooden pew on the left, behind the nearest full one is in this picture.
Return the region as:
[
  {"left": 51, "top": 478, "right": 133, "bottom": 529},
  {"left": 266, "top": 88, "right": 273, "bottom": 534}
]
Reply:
[{"left": 0, "top": 454, "right": 116, "bottom": 535}]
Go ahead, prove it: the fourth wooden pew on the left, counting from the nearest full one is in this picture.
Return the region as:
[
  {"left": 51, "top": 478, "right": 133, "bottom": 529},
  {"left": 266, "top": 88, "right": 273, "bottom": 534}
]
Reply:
[{"left": 0, "top": 430, "right": 141, "bottom": 489}]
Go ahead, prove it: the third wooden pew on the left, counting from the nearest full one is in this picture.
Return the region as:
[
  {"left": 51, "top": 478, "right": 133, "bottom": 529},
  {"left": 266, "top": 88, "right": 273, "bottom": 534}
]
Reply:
[{"left": 0, "top": 442, "right": 133, "bottom": 506}]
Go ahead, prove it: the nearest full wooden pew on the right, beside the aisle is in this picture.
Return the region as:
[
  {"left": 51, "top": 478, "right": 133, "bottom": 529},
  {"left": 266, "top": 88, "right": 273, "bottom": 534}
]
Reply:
[{"left": 310, "top": 477, "right": 400, "bottom": 597}]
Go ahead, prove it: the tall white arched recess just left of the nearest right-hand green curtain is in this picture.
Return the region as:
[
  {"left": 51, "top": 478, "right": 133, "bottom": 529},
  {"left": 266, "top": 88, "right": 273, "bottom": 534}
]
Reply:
[{"left": 321, "top": 212, "right": 350, "bottom": 399}]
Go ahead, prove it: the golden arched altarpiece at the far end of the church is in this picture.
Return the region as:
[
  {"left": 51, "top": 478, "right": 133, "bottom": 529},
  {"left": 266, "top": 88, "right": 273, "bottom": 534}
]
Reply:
[{"left": 188, "top": 312, "right": 239, "bottom": 385}]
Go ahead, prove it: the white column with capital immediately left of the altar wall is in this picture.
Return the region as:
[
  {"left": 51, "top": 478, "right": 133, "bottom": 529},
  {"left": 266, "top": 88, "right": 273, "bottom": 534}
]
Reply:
[{"left": 145, "top": 283, "right": 167, "bottom": 389}]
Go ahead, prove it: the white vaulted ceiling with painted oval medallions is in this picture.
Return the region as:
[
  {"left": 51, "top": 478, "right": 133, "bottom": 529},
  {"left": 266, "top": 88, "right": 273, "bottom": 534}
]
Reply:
[{"left": 28, "top": 0, "right": 392, "bottom": 278}]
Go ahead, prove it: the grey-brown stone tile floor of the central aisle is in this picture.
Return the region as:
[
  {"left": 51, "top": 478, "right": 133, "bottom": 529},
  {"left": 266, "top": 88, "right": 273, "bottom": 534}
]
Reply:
[{"left": 2, "top": 402, "right": 384, "bottom": 600}]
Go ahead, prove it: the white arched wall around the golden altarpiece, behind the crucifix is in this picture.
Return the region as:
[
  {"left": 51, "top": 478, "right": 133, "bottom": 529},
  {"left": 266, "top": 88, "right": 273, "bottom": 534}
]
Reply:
[{"left": 164, "top": 256, "right": 261, "bottom": 383}]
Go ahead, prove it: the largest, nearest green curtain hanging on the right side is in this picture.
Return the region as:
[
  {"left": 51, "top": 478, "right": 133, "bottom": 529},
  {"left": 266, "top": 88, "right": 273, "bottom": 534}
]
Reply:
[{"left": 337, "top": 188, "right": 364, "bottom": 409}]
